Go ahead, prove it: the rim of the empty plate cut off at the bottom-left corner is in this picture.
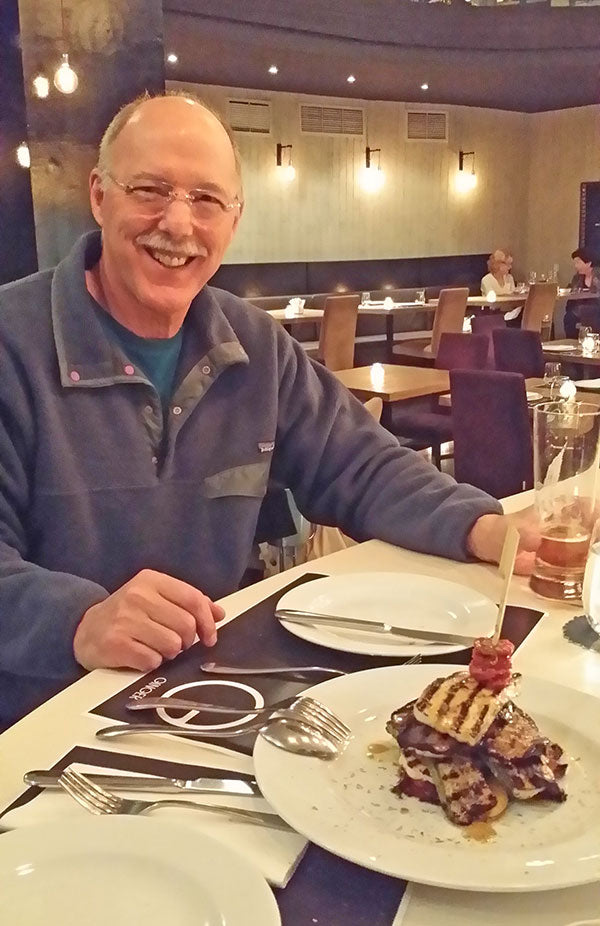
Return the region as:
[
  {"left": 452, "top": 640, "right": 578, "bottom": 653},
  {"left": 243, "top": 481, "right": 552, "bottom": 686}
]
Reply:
[{"left": 0, "top": 815, "right": 281, "bottom": 926}]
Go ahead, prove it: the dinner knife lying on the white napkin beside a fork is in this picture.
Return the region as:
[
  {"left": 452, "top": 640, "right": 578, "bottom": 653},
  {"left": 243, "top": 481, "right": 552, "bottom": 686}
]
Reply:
[{"left": 23, "top": 770, "right": 262, "bottom": 797}]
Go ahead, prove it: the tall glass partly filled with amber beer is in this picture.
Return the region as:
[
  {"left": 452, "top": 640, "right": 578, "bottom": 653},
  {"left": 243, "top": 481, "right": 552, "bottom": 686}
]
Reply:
[{"left": 530, "top": 401, "right": 600, "bottom": 603}]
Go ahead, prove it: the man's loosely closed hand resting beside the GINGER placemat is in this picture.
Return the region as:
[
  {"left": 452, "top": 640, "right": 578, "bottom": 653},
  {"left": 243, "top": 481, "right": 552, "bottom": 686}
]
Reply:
[{"left": 73, "top": 569, "right": 225, "bottom": 672}]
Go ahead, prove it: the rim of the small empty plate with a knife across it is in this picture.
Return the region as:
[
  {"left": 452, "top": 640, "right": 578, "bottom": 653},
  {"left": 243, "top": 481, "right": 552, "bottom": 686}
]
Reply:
[{"left": 275, "top": 571, "right": 497, "bottom": 658}]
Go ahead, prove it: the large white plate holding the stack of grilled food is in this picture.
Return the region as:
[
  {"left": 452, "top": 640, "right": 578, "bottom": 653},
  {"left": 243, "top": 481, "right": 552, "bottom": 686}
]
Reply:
[{"left": 254, "top": 665, "right": 600, "bottom": 891}]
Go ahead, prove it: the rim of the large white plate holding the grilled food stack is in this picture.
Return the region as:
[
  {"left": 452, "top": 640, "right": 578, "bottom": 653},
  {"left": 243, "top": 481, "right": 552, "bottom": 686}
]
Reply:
[{"left": 253, "top": 664, "right": 600, "bottom": 893}]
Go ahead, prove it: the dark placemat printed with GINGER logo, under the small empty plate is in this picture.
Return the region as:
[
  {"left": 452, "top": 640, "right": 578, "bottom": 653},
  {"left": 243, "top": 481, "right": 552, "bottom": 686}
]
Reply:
[{"left": 92, "top": 573, "right": 543, "bottom": 755}]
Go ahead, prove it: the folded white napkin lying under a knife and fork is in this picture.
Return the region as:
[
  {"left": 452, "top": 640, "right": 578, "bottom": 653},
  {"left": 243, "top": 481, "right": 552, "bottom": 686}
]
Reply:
[{"left": 2, "top": 762, "right": 307, "bottom": 887}]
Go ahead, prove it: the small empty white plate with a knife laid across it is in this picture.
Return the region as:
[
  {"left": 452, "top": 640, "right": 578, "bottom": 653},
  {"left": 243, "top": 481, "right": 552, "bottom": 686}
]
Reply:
[{"left": 277, "top": 572, "right": 498, "bottom": 656}]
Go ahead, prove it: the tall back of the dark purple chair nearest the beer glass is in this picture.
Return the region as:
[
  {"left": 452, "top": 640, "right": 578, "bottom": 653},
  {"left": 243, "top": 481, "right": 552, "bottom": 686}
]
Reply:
[{"left": 450, "top": 370, "right": 533, "bottom": 498}]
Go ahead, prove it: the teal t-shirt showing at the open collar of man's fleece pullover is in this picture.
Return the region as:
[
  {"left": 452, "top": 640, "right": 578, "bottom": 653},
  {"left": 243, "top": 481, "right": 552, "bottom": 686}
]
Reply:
[{"left": 99, "top": 310, "right": 183, "bottom": 408}]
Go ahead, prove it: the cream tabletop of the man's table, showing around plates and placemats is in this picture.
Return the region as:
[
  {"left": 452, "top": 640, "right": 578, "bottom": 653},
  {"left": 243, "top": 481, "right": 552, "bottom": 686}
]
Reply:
[{"left": 0, "top": 493, "right": 600, "bottom": 926}]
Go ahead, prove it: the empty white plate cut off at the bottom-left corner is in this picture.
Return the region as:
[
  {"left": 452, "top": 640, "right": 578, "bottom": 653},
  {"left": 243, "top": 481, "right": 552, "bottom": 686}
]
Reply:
[{"left": 0, "top": 816, "right": 281, "bottom": 926}]
